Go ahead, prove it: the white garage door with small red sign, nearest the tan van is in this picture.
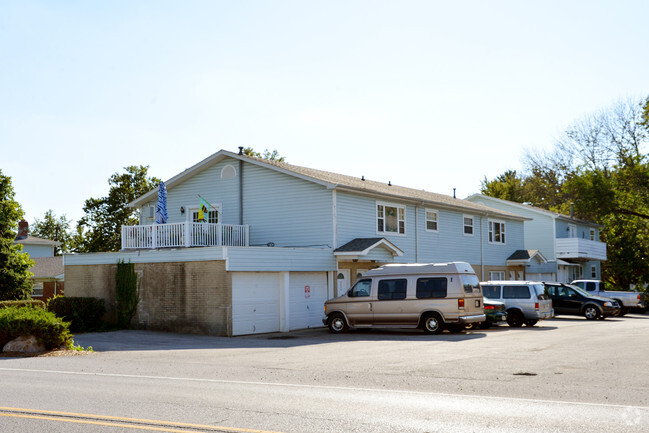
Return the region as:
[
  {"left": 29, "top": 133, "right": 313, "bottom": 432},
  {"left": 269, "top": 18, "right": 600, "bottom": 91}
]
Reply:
[{"left": 289, "top": 272, "right": 327, "bottom": 329}]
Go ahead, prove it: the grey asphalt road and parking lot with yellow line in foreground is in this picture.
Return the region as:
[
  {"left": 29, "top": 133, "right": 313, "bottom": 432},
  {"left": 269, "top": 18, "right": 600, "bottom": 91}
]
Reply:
[{"left": 0, "top": 315, "right": 649, "bottom": 433}]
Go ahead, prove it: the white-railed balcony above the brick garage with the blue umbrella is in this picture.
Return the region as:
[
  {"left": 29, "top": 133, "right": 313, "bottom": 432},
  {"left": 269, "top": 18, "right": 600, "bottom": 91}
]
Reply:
[{"left": 122, "top": 223, "right": 250, "bottom": 250}]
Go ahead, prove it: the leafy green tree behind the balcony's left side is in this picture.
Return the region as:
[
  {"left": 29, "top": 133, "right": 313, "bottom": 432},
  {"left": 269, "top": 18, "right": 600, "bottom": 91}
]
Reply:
[{"left": 72, "top": 165, "right": 161, "bottom": 252}]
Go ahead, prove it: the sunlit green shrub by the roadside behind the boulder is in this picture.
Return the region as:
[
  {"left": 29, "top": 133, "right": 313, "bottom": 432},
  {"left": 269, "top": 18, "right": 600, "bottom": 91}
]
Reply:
[{"left": 0, "top": 307, "right": 72, "bottom": 349}]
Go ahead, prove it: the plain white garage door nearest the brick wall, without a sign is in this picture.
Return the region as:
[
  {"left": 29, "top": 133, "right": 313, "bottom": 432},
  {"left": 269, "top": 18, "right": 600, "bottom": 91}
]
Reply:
[{"left": 232, "top": 272, "right": 279, "bottom": 335}]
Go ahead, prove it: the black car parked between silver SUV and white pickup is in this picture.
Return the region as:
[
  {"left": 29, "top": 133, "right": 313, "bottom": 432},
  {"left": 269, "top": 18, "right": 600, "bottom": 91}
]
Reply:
[{"left": 543, "top": 283, "right": 620, "bottom": 320}]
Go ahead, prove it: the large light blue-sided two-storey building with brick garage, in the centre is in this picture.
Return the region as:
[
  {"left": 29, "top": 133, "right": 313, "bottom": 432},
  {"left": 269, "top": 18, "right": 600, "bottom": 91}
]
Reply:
[{"left": 65, "top": 149, "right": 526, "bottom": 335}]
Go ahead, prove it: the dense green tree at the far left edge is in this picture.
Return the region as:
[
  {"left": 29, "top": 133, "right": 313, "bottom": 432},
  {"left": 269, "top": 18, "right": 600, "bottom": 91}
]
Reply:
[{"left": 0, "top": 170, "right": 34, "bottom": 301}]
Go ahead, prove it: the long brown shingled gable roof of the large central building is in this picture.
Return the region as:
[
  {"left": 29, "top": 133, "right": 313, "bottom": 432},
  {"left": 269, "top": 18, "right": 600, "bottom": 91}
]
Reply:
[{"left": 128, "top": 150, "right": 529, "bottom": 221}]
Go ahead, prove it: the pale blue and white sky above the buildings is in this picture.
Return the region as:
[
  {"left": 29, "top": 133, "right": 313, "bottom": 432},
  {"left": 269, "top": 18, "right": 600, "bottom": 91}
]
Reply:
[{"left": 0, "top": 0, "right": 649, "bottom": 223}]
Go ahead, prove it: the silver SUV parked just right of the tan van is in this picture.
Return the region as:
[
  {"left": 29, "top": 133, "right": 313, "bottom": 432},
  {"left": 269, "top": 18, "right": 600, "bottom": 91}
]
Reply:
[{"left": 480, "top": 281, "right": 554, "bottom": 328}]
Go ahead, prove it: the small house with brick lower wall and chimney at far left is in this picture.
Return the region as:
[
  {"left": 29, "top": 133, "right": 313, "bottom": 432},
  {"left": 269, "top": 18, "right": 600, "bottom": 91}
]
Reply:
[{"left": 14, "top": 220, "right": 64, "bottom": 301}]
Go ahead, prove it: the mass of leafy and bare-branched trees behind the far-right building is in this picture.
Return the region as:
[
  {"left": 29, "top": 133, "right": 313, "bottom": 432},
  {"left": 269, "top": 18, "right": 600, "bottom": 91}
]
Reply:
[{"left": 482, "top": 98, "right": 649, "bottom": 287}]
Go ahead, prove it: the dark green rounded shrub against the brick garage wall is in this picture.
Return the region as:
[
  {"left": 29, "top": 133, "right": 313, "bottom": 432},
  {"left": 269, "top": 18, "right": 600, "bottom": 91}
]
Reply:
[{"left": 47, "top": 296, "right": 106, "bottom": 332}]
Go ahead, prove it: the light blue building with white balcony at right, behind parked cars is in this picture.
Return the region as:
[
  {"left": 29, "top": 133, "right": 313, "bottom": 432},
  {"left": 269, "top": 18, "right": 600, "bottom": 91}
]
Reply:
[{"left": 467, "top": 194, "right": 606, "bottom": 282}]
